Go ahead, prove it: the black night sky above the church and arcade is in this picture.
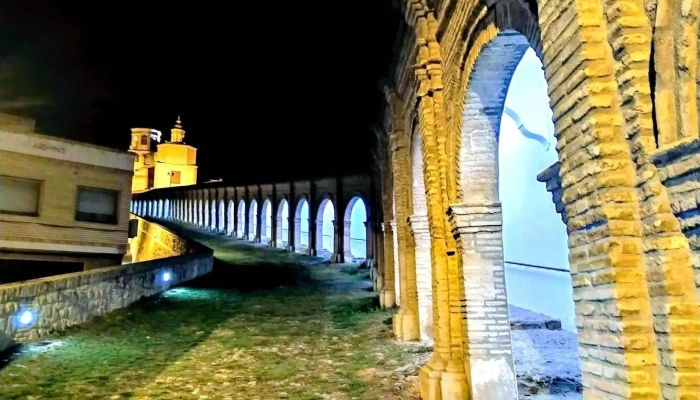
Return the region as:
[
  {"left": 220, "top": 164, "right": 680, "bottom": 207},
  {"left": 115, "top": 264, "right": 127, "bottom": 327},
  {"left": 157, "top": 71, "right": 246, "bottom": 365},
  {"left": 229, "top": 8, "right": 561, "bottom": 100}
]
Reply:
[{"left": 0, "top": 0, "right": 399, "bottom": 183}]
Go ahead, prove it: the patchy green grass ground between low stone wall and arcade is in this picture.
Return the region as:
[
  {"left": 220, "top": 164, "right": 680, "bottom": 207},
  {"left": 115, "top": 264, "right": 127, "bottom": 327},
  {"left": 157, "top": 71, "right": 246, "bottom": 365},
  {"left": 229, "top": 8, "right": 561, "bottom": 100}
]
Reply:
[{"left": 0, "top": 225, "right": 425, "bottom": 400}]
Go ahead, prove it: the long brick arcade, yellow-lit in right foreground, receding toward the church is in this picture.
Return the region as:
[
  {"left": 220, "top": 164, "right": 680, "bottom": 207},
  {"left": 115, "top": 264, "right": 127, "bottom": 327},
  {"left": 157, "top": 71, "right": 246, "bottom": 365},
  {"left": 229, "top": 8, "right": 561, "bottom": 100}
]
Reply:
[{"left": 136, "top": 0, "right": 700, "bottom": 400}]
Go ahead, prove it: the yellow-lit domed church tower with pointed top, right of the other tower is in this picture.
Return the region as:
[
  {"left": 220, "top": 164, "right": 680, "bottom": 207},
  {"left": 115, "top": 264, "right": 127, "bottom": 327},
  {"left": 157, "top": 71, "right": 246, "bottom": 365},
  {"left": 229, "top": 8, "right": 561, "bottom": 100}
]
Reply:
[{"left": 153, "top": 116, "right": 197, "bottom": 188}]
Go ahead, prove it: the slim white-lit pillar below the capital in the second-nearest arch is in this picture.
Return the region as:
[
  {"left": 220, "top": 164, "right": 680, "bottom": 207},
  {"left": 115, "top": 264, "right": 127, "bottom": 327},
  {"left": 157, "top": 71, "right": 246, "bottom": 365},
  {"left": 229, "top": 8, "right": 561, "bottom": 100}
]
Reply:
[{"left": 408, "top": 215, "right": 433, "bottom": 340}]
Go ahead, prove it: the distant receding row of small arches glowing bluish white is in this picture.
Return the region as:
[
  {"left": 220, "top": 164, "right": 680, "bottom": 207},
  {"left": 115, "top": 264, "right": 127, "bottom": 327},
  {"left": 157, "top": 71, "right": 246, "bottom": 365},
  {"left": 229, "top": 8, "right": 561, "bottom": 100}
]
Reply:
[{"left": 131, "top": 196, "right": 369, "bottom": 261}]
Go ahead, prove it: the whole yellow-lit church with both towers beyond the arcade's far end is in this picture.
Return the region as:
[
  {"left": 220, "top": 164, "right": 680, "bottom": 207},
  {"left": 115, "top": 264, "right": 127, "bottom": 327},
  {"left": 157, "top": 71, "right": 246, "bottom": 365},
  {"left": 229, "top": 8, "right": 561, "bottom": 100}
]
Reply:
[{"left": 129, "top": 116, "right": 197, "bottom": 192}]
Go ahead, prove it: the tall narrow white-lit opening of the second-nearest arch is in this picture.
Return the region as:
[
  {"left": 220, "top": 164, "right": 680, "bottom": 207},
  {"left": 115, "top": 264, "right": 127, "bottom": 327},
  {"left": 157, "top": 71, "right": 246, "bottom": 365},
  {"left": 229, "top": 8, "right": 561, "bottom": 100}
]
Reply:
[{"left": 409, "top": 124, "right": 433, "bottom": 340}]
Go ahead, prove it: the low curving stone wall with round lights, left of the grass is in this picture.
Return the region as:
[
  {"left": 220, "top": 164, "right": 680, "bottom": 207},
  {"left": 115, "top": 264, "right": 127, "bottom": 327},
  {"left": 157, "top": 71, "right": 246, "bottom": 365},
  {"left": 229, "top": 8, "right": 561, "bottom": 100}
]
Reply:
[{"left": 0, "top": 220, "right": 213, "bottom": 351}]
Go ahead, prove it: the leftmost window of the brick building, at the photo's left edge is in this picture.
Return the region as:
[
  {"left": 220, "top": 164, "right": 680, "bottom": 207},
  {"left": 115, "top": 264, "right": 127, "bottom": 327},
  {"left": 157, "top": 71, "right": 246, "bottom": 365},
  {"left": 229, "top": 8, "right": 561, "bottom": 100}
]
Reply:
[{"left": 0, "top": 176, "right": 41, "bottom": 216}]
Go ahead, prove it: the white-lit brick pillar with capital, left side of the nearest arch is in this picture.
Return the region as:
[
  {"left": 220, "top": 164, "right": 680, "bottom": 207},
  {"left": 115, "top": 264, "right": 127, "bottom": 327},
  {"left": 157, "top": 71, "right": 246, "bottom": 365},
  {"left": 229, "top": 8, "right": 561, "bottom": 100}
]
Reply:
[{"left": 448, "top": 201, "right": 518, "bottom": 400}]
